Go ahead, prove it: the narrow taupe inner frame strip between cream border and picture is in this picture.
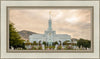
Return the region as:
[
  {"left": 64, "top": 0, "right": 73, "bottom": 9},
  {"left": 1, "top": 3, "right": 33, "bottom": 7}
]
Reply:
[{"left": 6, "top": 6, "right": 94, "bottom": 53}]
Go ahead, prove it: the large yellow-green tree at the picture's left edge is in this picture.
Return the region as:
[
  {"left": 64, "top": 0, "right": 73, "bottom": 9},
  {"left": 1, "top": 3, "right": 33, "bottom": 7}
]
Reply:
[{"left": 9, "top": 23, "right": 25, "bottom": 49}]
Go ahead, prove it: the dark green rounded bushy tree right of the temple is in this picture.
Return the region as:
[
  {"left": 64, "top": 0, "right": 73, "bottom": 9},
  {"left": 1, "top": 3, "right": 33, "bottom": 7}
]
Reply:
[{"left": 77, "top": 38, "right": 91, "bottom": 49}]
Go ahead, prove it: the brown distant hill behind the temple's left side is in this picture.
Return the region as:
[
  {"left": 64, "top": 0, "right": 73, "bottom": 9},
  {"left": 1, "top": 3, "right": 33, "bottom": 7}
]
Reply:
[{"left": 18, "top": 30, "right": 37, "bottom": 40}]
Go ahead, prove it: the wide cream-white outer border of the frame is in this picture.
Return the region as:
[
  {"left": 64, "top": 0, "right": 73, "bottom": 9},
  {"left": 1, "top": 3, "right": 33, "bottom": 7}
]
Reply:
[{"left": 1, "top": 1, "right": 99, "bottom": 58}]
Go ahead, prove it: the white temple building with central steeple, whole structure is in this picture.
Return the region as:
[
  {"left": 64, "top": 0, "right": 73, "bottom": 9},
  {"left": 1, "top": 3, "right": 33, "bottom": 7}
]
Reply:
[{"left": 29, "top": 12, "right": 71, "bottom": 46}]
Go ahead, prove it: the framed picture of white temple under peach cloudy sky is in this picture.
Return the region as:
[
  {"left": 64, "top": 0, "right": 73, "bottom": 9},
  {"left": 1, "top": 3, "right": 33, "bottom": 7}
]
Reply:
[{"left": 7, "top": 7, "right": 93, "bottom": 51}]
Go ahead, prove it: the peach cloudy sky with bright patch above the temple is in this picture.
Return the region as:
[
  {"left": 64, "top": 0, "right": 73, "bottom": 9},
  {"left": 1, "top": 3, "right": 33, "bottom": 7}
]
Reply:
[{"left": 9, "top": 8, "right": 92, "bottom": 40}]
